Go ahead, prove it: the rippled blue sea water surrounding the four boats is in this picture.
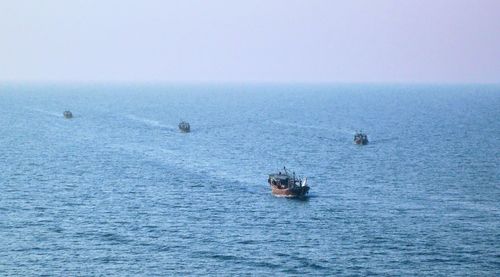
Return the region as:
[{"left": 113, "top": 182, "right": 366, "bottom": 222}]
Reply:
[{"left": 0, "top": 84, "right": 500, "bottom": 276}]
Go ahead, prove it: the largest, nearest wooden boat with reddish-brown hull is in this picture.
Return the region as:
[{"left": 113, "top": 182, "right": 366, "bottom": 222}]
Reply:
[{"left": 267, "top": 167, "right": 309, "bottom": 198}]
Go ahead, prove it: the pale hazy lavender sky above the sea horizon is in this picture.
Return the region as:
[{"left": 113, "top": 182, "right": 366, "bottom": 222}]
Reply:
[{"left": 0, "top": 0, "right": 500, "bottom": 82}]
